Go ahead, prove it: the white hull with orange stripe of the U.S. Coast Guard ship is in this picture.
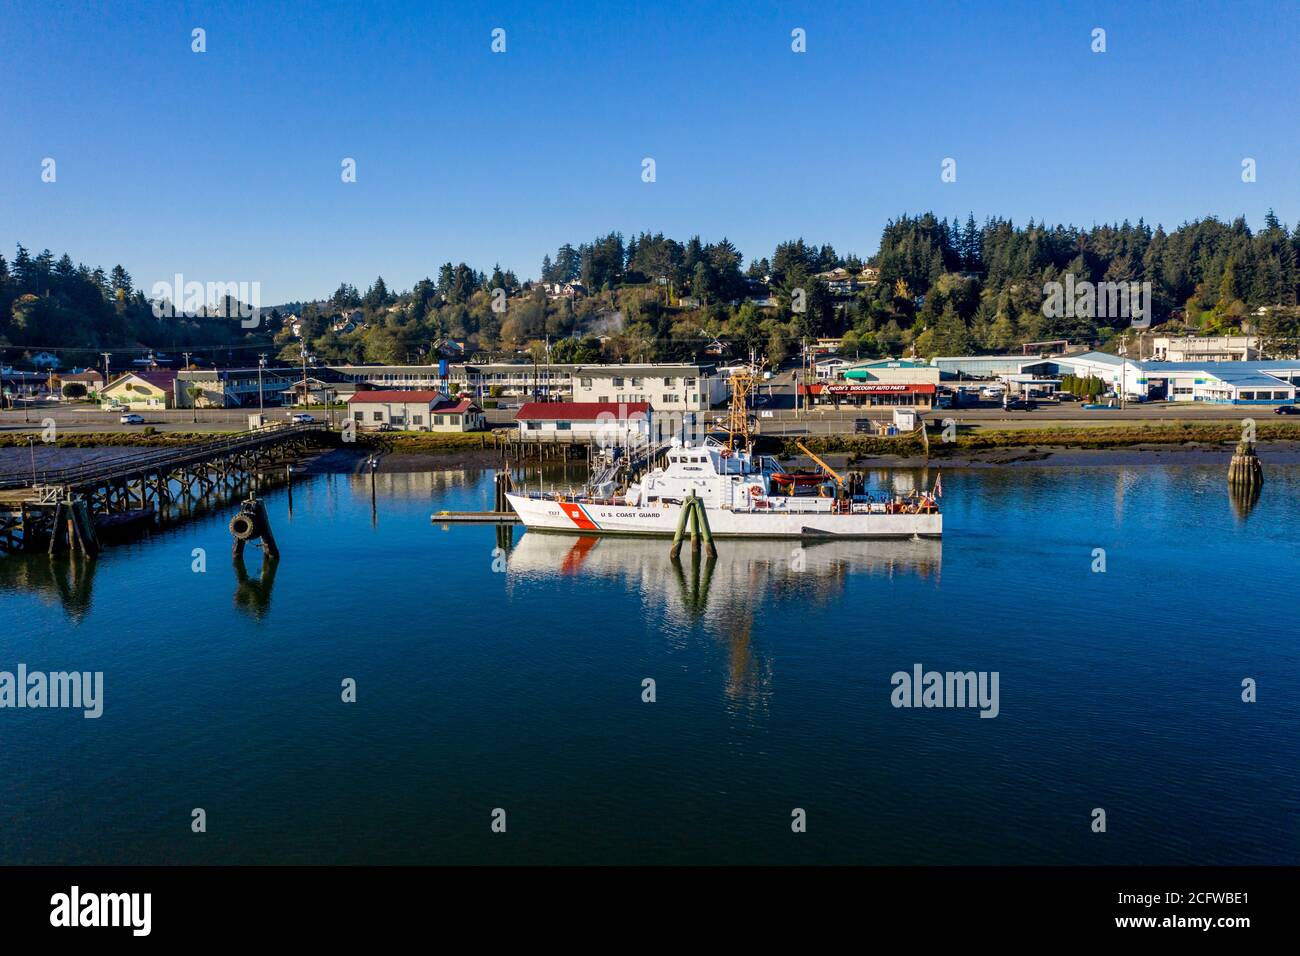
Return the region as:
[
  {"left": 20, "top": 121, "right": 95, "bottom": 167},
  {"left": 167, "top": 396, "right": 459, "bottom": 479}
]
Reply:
[{"left": 506, "top": 494, "right": 944, "bottom": 538}]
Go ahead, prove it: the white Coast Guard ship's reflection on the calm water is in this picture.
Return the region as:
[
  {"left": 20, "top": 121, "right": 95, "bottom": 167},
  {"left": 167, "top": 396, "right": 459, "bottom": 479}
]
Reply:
[{"left": 507, "top": 531, "right": 943, "bottom": 702}]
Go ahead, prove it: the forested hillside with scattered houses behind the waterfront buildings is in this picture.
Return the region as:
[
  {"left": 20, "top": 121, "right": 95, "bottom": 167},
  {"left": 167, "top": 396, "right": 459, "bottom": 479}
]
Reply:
[{"left": 0, "top": 213, "right": 1300, "bottom": 364}]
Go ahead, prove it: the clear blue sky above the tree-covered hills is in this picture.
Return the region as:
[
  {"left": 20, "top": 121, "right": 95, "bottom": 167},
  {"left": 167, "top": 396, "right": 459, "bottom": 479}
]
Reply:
[{"left": 0, "top": 0, "right": 1300, "bottom": 304}]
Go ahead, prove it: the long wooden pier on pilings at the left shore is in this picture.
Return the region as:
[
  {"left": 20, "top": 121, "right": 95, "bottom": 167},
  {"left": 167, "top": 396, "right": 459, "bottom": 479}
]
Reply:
[{"left": 0, "top": 423, "right": 330, "bottom": 554}]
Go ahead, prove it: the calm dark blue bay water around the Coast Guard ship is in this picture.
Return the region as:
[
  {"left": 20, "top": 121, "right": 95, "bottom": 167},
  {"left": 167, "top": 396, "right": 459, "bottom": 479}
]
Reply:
[{"left": 0, "top": 466, "right": 1300, "bottom": 864}]
